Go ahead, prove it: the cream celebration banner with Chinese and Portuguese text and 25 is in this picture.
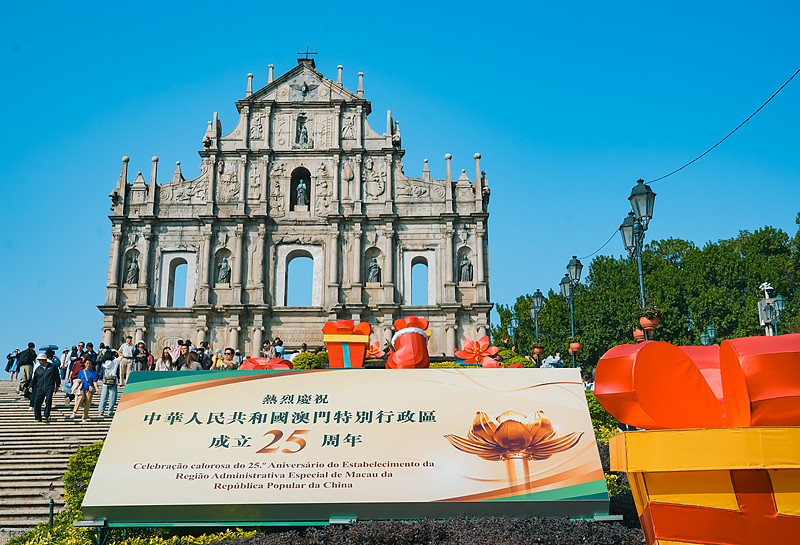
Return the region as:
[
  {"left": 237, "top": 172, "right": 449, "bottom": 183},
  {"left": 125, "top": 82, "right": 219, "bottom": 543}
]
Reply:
[{"left": 83, "top": 368, "right": 608, "bottom": 522}]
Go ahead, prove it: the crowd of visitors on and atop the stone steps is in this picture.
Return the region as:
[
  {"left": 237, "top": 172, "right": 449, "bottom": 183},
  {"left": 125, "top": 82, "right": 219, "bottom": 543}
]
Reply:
[{"left": 6, "top": 335, "right": 322, "bottom": 422}]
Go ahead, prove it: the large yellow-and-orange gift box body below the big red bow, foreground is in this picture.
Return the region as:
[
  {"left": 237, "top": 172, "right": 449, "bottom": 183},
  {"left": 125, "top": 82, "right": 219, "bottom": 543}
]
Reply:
[{"left": 610, "top": 427, "right": 800, "bottom": 545}]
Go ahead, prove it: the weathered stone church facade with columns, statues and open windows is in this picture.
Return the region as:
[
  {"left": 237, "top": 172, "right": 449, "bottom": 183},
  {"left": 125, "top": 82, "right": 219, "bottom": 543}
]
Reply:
[{"left": 99, "top": 59, "right": 492, "bottom": 355}]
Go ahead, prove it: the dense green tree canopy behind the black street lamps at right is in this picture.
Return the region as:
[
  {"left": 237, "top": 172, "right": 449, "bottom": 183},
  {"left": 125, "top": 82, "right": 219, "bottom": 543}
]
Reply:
[{"left": 492, "top": 214, "right": 800, "bottom": 369}]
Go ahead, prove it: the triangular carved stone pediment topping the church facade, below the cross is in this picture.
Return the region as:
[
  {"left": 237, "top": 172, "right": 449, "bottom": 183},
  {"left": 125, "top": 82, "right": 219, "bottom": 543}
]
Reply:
[{"left": 248, "top": 65, "right": 358, "bottom": 102}]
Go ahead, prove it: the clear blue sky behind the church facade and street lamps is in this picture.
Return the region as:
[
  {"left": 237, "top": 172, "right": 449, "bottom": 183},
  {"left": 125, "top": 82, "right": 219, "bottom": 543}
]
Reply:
[{"left": 0, "top": 1, "right": 800, "bottom": 370}]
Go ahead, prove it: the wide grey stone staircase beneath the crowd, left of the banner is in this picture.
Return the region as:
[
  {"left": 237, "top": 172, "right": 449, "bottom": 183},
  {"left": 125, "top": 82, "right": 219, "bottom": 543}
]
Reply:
[{"left": 0, "top": 380, "right": 116, "bottom": 543}]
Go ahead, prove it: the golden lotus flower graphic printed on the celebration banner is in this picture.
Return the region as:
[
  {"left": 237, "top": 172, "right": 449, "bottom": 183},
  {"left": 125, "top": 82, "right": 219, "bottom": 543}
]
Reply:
[{"left": 445, "top": 411, "right": 583, "bottom": 486}]
